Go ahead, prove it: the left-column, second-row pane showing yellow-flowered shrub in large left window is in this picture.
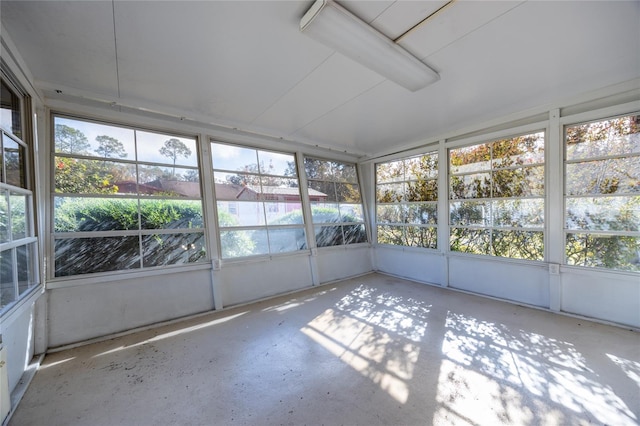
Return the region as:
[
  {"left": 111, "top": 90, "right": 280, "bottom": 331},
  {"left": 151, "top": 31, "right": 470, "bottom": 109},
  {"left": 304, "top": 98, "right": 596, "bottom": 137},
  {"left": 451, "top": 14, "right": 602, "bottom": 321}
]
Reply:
[{"left": 54, "top": 157, "right": 130, "bottom": 194}]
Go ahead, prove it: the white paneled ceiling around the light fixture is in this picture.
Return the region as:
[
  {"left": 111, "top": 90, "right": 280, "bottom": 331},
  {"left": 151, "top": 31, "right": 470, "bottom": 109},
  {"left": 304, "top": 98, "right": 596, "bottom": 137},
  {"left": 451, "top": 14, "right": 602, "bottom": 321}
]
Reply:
[{"left": 0, "top": 0, "right": 640, "bottom": 156}]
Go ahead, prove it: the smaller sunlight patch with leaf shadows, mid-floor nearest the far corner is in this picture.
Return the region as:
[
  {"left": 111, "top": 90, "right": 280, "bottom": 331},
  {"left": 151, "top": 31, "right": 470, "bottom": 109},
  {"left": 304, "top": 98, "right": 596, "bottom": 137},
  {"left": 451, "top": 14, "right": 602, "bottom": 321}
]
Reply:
[{"left": 301, "top": 286, "right": 429, "bottom": 404}]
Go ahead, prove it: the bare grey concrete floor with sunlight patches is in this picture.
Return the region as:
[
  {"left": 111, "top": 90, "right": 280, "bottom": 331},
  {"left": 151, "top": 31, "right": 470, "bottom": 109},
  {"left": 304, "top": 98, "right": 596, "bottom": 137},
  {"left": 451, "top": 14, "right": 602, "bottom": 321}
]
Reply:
[{"left": 9, "top": 274, "right": 640, "bottom": 426}]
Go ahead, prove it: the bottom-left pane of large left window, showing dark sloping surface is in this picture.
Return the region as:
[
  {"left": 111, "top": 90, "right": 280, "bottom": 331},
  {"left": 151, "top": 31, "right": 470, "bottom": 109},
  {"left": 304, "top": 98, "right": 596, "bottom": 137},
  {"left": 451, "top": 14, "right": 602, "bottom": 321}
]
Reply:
[{"left": 55, "top": 236, "right": 140, "bottom": 277}]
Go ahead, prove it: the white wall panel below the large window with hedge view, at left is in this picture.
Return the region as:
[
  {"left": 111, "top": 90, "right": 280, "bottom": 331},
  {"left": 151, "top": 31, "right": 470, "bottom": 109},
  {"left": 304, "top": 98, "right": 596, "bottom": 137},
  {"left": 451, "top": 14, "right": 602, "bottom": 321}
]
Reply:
[{"left": 48, "top": 269, "right": 214, "bottom": 348}]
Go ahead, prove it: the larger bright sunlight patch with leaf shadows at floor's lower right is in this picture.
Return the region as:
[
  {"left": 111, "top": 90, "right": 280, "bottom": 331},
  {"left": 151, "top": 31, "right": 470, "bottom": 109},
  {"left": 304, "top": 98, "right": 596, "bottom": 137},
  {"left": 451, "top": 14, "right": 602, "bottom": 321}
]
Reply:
[{"left": 434, "top": 312, "right": 640, "bottom": 425}]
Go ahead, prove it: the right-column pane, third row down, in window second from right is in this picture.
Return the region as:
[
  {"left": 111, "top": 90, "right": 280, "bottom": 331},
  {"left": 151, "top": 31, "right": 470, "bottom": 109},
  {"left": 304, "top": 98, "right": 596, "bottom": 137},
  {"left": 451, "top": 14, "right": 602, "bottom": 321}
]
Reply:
[{"left": 492, "top": 199, "right": 544, "bottom": 228}]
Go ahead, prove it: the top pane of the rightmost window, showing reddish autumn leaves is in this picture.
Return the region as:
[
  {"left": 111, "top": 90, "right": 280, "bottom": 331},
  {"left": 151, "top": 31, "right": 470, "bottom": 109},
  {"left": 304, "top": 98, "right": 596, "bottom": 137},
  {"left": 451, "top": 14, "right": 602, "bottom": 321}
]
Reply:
[{"left": 566, "top": 115, "right": 640, "bottom": 160}]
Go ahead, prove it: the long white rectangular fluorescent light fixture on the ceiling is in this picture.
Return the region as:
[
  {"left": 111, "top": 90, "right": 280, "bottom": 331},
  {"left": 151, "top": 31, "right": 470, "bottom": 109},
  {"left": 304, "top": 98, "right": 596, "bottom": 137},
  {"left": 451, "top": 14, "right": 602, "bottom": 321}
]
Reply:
[{"left": 300, "top": 0, "right": 440, "bottom": 92}]
